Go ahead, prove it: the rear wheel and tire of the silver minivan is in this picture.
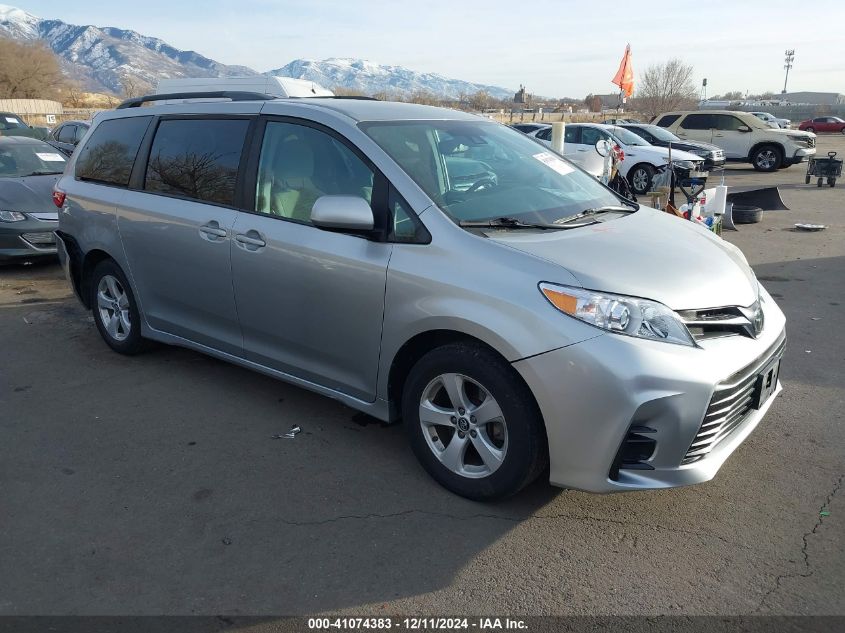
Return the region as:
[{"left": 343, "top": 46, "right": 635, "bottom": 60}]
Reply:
[{"left": 90, "top": 259, "right": 146, "bottom": 356}]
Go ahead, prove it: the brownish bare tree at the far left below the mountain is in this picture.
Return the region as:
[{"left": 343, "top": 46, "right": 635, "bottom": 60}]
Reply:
[{"left": 0, "top": 38, "right": 65, "bottom": 99}]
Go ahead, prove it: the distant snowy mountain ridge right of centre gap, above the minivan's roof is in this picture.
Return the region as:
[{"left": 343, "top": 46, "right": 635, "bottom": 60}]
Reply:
[{"left": 266, "top": 57, "right": 514, "bottom": 99}]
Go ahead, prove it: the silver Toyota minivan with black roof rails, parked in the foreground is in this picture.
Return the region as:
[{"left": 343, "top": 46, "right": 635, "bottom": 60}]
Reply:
[{"left": 54, "top": 94, "right": 785, "bottom": 499}]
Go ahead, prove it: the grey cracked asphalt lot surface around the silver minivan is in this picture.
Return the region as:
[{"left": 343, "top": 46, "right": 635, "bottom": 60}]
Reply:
[{"left": 0, "top": 136, "right": 845, "bottom": 615}]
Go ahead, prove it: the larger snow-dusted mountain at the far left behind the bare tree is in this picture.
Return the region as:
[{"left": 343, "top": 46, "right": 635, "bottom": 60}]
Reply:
[{"left": 0, "top": 4, "right": 257, "bottom": 92}]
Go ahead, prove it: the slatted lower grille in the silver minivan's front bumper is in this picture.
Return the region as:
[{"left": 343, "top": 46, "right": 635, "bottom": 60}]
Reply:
[{"left": 681, "top": 337, "right": 786, "bottom": 464}]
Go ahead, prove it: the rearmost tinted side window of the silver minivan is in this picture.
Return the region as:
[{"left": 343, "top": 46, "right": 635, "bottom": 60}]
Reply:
[{"left": 76, "top": 116, "right": 152, "bottom": 187}]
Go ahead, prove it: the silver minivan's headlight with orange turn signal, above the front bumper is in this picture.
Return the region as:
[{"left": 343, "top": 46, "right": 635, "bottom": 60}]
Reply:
[{"left": 539, "top": 282, "right": 695, "bottom": 347}]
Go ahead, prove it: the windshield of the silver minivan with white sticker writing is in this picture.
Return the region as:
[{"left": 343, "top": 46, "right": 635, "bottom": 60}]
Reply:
[{"left": 359, "top": 121, "right": 620, "bottom": 224}]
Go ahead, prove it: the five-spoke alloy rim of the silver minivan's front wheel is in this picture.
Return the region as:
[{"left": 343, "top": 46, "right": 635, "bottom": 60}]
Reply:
[{"left": 419, "top": 373, "right": 508, "bottom": 479}]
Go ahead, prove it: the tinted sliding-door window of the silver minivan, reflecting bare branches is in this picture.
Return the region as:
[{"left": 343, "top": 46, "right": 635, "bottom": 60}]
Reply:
[{"left": 144, "top": 119, "right": 249, "bottom": 206}]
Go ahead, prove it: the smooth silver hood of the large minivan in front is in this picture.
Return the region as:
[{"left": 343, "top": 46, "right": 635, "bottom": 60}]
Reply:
[{"left": 487, "top": 207, "right": 757, "bottom": 310}]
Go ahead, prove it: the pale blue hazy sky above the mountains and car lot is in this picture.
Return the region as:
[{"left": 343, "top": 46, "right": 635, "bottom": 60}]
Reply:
[{"left": 14, "top": 0, "right": 845, "bottom": 97}]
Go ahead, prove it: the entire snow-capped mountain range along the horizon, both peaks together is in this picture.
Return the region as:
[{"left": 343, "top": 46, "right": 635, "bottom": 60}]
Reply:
[{"left": 0, "top": 4, "right": 513, "bottom": 98}]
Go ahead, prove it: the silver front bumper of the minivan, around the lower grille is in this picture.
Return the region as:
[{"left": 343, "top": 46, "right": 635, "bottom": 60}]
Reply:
[{"left": 514, "top": 295, "right": 785, "bottom": 492}]
